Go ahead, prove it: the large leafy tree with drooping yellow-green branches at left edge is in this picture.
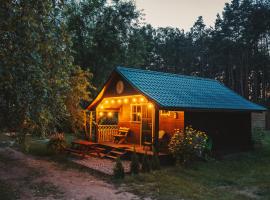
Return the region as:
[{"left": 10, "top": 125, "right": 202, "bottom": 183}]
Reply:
[{"left": 0, "top": 0, "right": 92, "bottom": 135}]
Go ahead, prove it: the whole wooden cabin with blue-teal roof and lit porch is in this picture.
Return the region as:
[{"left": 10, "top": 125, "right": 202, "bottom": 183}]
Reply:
[{"left": 86, "top": 67, "right": 265, "bottom": 150}]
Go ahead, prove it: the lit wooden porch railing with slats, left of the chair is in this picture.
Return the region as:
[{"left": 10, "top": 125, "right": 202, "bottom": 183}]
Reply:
[{"left": 98, "top": 125, "right": 118, "bottom": 142}]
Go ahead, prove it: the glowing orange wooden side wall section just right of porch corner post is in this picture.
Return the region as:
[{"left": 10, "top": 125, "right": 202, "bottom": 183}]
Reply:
[{"left": 159, "top": 111, "right": 184, "bottom": 136}]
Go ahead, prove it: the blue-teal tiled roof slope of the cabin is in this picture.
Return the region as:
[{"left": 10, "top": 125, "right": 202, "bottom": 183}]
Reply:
[{"left": 116, "top": 67, "right": 266, "bottom": 111}]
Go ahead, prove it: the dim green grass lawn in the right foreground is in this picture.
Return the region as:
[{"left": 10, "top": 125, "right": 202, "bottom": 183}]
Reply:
[{"left": 124, "top": 132, "right": 270, "bottom": 200}]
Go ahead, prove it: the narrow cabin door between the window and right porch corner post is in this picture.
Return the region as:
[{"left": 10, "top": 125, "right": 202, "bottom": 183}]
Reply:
[{"left": 140, "top": 105, "right": 153, "bottom": 145}]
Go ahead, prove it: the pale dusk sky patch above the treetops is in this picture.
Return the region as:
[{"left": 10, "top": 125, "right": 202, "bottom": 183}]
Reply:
[{"left": 135, "top": 0, "right": 231, "bottom": 31}]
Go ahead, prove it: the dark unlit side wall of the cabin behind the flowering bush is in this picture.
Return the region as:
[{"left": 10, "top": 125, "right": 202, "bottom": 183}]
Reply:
[{"left": 185, "top": 112, "right": 252, "bottom": 151}]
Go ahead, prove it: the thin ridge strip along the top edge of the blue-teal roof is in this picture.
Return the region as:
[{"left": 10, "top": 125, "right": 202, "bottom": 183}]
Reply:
[{"left": 116, "top": 66, "right": 219, "bottom": 82}]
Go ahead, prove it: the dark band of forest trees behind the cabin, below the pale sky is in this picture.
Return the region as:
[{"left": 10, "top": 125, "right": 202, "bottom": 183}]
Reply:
[{"left": 65, "top": 0, "right": 270, "bottom": 105}]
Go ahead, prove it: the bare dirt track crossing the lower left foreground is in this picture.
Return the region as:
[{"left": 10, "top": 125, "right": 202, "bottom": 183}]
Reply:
[{"left": 0, "top": 148, "right": 150, "bottom": 200}]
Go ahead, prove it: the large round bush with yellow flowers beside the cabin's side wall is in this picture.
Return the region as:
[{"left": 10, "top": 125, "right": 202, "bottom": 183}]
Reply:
[{"left": 169, "top": 126, "right": 208, "bottom": 165}]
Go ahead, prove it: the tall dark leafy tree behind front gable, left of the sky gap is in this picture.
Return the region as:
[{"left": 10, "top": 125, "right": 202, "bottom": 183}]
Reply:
[{"left": 65, "top": 0, "right": 139, "bottom": 87}]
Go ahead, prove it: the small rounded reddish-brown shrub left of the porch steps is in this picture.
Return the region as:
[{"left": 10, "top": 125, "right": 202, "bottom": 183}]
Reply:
[{"left": 47, "top": 133, "right": 67, "bottom": 153}]
